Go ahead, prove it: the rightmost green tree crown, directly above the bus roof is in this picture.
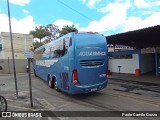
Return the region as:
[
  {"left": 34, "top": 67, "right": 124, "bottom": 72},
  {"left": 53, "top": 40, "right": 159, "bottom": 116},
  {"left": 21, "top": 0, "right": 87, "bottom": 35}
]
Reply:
[{"left": 59, "top": 25, "right": 77, "bottom": 37}]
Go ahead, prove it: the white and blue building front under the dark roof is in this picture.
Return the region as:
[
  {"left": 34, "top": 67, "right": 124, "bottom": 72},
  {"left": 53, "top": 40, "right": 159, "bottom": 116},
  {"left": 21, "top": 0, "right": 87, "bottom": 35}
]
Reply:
[{"left": 109, "top": 47, "right": 160, "bottom": 74}]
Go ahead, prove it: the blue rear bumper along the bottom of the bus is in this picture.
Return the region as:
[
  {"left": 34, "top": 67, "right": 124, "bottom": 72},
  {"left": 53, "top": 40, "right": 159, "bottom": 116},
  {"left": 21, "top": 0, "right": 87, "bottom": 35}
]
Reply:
[{"left": 71, "top": 80, "right": 108, "bottom": 94}]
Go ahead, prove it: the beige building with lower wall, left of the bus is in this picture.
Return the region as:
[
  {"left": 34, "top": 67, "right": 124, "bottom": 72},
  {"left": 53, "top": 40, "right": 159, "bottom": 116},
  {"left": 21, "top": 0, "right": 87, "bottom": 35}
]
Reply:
[{"left": 0, "top": 32, "right": 33, "bottom": 73}]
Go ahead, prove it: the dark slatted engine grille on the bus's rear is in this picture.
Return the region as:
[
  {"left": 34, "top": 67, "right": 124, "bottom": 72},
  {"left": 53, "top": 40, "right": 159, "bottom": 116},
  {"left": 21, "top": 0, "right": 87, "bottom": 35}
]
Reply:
[{"left": 80, "top": 59, "right": 104, "bottom": 67}]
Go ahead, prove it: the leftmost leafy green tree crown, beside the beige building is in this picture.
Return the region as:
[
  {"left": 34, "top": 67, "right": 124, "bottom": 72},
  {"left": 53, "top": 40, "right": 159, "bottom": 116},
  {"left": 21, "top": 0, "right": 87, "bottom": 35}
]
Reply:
[{"left": 30, "top": 26, "right": 51, "bottom": 43}]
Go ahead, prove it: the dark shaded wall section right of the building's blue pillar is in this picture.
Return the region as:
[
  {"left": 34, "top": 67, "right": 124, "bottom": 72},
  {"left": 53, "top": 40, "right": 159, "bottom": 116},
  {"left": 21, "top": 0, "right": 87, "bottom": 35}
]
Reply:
[{"left": 141, "top": 54, "right": 155, "bottom": 74}]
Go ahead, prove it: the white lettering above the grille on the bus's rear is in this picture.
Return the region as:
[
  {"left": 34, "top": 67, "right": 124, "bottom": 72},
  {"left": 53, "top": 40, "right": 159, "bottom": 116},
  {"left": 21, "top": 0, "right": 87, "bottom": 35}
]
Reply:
[{"left": 79, "top": 51, "right": 106, "bottom": 56}]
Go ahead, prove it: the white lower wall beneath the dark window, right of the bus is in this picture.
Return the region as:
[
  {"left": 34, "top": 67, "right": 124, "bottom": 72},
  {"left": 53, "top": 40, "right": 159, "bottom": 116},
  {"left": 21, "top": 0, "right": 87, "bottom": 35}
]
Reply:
[{"left": 109, "top": 54, "right": 139, "bottom": 74}]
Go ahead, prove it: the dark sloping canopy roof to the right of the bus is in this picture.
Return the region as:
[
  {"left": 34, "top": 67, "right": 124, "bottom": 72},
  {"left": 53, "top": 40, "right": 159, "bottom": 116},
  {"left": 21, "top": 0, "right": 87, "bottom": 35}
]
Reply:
[{"left": 106, "top": 25, "right": 160, "bottom": 49}]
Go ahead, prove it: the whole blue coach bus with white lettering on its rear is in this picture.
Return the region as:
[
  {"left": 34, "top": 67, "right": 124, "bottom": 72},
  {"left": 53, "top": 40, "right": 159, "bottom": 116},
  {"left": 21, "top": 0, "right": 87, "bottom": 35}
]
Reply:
[{"left": 33, "top": 32, "right": 108, "bottom": 94}]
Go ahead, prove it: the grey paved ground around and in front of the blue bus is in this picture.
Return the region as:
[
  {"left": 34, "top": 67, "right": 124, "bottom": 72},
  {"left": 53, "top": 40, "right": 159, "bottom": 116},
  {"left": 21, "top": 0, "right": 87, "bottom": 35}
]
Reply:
[{"left": 0, "top": 73, "right": 160, "bottom": 120}]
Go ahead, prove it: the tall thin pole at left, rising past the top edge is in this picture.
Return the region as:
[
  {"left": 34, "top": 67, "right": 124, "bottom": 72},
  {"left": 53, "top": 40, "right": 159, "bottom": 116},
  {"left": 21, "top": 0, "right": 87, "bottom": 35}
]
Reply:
[{"left": 7, "top": 0, "right": 18, "bottom": 97}]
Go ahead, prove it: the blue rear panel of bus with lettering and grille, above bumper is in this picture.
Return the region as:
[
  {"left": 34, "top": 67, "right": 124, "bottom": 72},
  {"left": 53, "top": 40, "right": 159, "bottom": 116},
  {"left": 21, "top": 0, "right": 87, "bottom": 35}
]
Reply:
[{"left": 75, "top": 33, "right": 107, "bottom": 85}]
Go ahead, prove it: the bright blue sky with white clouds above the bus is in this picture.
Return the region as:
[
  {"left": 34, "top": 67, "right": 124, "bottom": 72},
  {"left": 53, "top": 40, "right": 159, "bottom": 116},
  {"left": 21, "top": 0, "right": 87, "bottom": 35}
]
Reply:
[{"left": 0, "top": 0, "right": 160, "bottom": 36}]
